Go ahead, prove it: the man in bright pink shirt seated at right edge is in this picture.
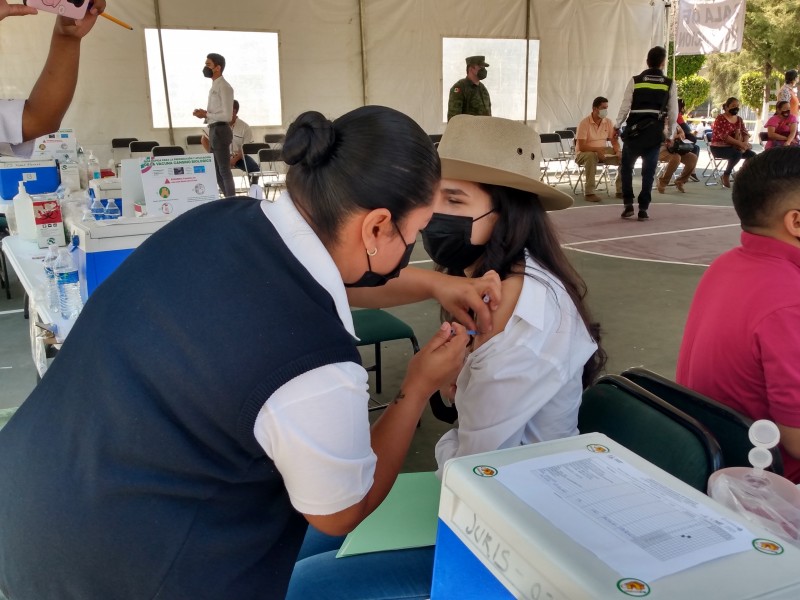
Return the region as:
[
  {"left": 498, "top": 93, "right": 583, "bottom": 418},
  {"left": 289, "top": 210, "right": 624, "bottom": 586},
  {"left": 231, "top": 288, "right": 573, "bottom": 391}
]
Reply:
[{"left": 677, "top": 147, "right": 800, "bottom": 483}]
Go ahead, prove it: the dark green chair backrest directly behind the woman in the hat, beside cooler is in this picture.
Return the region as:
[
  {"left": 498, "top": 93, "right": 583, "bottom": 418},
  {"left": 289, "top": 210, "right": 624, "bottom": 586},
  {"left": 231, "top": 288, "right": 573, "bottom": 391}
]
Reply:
[{"left": 578, "top": 375, "right": 722, "bottom": 492}]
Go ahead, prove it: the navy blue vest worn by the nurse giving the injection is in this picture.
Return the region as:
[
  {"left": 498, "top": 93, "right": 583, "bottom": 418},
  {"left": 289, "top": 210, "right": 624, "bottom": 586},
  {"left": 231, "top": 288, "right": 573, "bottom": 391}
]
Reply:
[{"left": 0, "top": 200, "right": 360, "bottom": 600}]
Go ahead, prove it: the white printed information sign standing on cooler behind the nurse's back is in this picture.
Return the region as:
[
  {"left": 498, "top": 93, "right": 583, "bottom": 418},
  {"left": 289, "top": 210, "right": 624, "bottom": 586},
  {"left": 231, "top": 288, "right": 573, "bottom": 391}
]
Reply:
[{"left": 140, "top": 154, "right": 219, "bottom": 217}]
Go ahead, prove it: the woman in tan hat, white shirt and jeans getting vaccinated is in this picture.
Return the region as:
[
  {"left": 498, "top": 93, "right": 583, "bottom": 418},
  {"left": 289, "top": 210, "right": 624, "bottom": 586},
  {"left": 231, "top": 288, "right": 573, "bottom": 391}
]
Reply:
[{"left": 287, "top": 115, "right": 605, "bottom": 600}]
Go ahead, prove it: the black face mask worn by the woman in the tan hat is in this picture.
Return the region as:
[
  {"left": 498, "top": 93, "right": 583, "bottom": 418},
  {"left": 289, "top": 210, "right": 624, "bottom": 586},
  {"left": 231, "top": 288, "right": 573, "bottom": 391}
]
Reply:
[{"left": 422, "top": 209, "right": 494, "bottom": 271}]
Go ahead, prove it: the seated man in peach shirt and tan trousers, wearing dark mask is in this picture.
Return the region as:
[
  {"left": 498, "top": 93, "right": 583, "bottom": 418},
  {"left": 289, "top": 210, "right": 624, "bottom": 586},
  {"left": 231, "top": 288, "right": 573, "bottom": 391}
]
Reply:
[{"left": 575, "top": 96, "right": 622, "bottom": 202}]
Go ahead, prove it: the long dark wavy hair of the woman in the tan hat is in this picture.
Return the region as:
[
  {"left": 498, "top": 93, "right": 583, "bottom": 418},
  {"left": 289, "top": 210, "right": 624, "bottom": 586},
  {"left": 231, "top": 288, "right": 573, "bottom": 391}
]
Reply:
[{"left": 444, "top": 184, "right": 608, "bottom": 388}]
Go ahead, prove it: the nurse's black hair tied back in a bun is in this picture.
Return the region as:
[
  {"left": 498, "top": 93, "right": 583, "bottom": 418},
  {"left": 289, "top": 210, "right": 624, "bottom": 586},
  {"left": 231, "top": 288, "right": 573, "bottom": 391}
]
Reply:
[{"left": 282, "top": 106, "right": 441, "bottom": 243}]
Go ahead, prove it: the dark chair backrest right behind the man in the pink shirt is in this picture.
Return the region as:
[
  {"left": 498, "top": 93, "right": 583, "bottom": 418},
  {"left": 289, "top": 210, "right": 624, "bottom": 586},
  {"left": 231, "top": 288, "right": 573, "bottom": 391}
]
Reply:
[{"left": 622, "top": 367, "right": 783, "bottom": 475}]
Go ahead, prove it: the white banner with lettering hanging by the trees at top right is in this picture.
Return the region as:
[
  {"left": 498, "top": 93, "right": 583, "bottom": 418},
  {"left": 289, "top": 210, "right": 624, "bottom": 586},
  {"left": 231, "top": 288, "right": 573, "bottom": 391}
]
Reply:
[{"left": 675, "top": 0, "right": 745, "bottom": 56}]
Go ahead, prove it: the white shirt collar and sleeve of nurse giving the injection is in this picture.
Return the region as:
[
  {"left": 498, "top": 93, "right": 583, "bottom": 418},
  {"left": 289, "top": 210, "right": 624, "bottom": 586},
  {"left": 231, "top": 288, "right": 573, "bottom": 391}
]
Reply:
[{"left": 254, "top": 192, "right": 377, "bottom": 515}]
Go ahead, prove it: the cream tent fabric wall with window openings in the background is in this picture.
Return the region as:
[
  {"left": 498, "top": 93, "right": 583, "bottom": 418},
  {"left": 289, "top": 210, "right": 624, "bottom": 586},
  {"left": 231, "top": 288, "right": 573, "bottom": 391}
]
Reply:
[{"left": 0, "top": 0, "right": 664, "bottom": 160}]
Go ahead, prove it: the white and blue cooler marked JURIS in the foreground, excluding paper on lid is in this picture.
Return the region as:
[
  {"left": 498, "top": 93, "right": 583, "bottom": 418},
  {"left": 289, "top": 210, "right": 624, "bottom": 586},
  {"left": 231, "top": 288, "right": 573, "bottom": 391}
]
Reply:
[{"left": 431, "top": 433, "right": 800, "bottom": 600}]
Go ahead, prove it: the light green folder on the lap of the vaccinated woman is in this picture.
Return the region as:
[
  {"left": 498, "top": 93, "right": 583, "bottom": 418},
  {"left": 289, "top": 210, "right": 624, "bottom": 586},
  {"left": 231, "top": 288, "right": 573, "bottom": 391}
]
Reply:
[{"left": 336, "top": 472, "right": 442, "bottom": 558}]
